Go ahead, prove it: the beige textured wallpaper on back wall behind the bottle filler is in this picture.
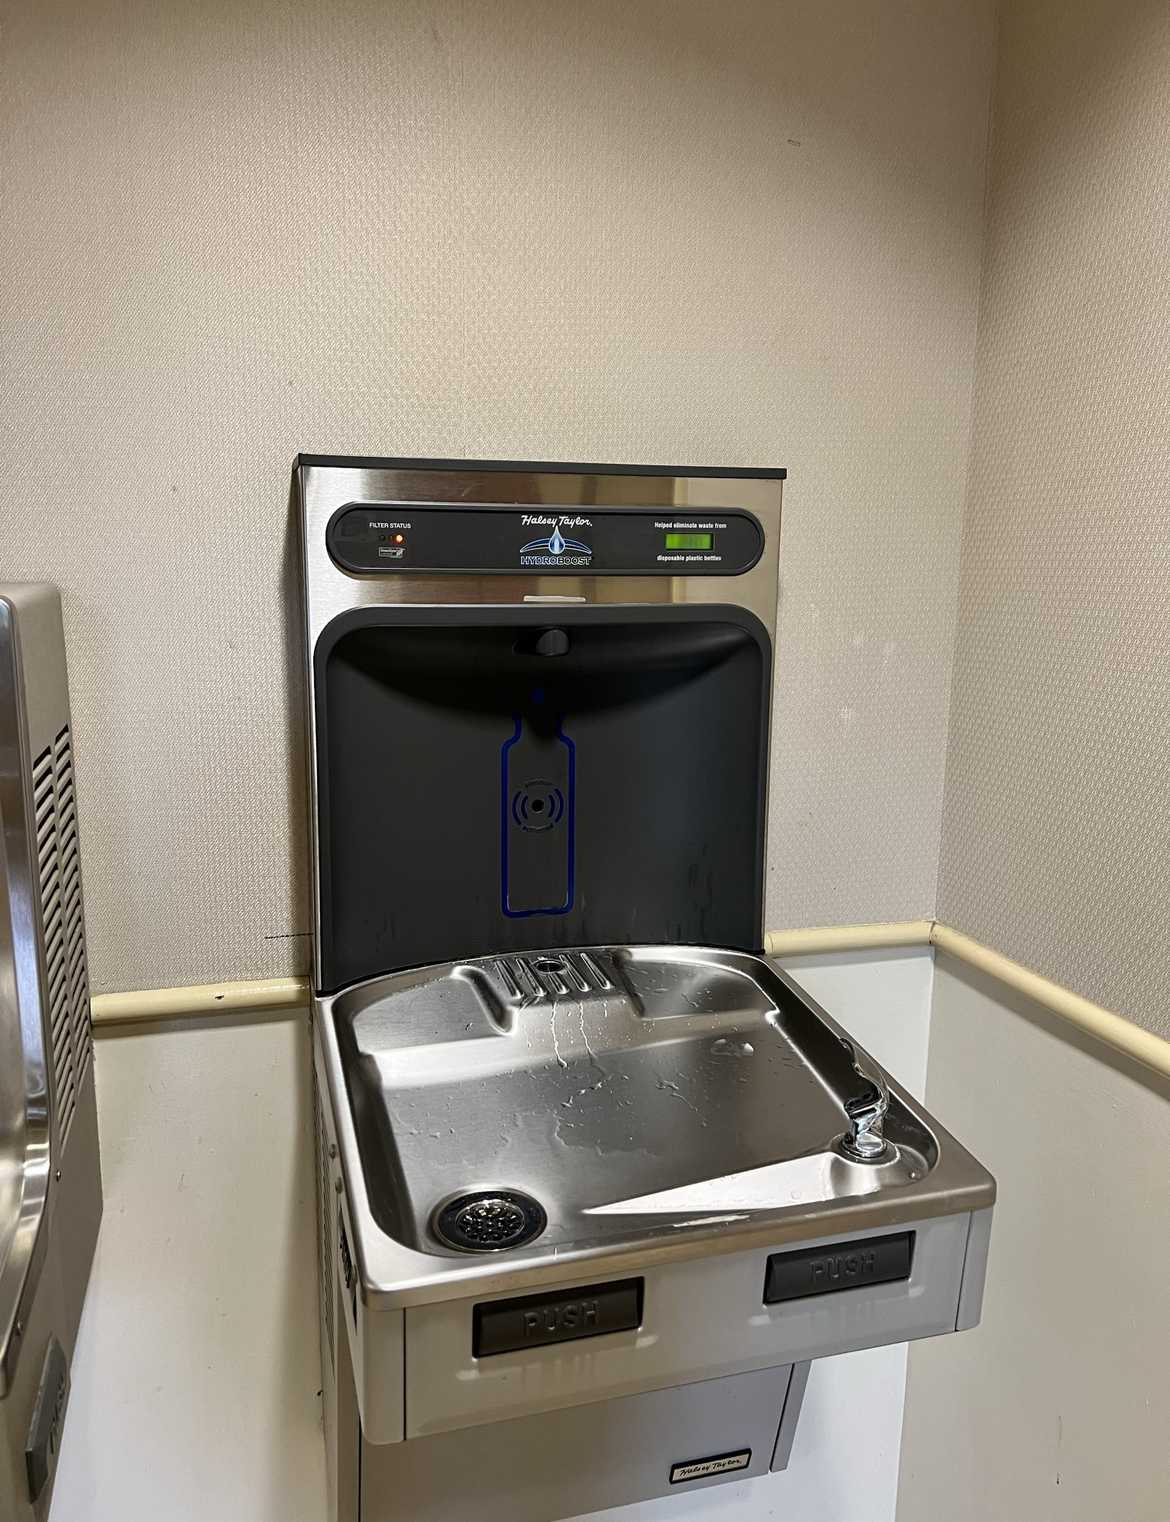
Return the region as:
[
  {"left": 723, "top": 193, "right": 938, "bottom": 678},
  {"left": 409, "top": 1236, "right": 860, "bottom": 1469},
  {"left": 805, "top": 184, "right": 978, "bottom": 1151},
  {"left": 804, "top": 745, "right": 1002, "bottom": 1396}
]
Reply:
[{"left": 0, "top": 0, "right": 992, "bottom": 989}]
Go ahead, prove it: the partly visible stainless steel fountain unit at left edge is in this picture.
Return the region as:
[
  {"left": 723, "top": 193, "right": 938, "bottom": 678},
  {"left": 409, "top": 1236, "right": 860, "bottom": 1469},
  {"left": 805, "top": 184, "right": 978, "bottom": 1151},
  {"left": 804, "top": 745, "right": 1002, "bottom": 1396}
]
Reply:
[{"left": 0, "top": 584, "right": 102, "bottom": 1522}]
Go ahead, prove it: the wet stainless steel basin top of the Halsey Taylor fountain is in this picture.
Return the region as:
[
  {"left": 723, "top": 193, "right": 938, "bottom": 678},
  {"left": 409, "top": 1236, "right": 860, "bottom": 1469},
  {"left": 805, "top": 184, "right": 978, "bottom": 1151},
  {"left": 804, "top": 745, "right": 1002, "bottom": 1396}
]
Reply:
[{"left": 326, "top": 947, "right": 994, "bottom": 1288}]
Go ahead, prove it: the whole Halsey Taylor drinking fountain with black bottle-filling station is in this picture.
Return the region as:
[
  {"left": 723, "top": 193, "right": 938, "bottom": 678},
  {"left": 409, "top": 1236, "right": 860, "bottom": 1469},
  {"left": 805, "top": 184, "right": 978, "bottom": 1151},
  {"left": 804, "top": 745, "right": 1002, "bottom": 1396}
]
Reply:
[{"left": 297, "top": 457, "right": 995, "bottom": 1522}]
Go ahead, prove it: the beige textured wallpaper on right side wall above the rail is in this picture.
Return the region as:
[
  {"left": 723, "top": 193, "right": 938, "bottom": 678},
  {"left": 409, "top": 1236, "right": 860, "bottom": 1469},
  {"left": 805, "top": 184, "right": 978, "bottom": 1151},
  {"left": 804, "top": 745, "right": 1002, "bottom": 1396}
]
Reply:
[{"left": 939, "top": 0, "right": 1170, "bottom": 1035}]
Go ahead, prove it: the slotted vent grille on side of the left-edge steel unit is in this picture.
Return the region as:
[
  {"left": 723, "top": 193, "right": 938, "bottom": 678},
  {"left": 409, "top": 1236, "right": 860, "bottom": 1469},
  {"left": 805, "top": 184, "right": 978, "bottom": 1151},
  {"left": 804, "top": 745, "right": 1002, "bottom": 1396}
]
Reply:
[{"left": 32, "top": 726, "right": 93, "bottom": 1146}]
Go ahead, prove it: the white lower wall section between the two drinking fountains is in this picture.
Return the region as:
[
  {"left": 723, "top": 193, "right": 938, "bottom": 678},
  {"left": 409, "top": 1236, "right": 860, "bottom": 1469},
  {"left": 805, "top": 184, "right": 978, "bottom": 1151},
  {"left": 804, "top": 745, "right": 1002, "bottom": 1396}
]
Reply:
[{"left": 50, "top": 1017, "right": 324, "bottom": 1522}]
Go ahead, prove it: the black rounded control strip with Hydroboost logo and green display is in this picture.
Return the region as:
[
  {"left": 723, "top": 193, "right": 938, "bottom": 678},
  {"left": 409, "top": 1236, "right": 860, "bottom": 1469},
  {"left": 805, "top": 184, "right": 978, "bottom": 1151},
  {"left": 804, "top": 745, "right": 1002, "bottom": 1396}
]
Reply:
[{"left": 326, "top": 502, "right": 764, "bottom": 575}]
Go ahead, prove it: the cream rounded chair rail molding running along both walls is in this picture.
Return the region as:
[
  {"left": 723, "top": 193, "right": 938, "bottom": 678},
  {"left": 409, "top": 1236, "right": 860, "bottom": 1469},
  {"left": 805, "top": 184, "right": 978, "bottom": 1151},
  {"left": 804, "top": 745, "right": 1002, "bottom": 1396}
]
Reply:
[{"left": 93, "top": 919, "right": 1170, "bottom": 1078}]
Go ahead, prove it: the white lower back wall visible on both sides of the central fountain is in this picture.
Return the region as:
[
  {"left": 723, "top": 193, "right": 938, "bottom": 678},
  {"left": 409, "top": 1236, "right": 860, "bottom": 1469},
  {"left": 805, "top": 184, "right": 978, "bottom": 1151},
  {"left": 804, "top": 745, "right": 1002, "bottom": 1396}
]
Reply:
[{"left": 53, "top": 948, "right": 931, "bottom": 1522}]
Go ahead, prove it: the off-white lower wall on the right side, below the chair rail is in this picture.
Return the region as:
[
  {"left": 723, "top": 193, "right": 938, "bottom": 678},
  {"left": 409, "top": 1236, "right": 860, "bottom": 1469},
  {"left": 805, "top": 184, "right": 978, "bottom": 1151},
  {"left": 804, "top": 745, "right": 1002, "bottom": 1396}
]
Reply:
[{"left": 898, "top": 956, "right": 1170, "bottom": 1522}]
